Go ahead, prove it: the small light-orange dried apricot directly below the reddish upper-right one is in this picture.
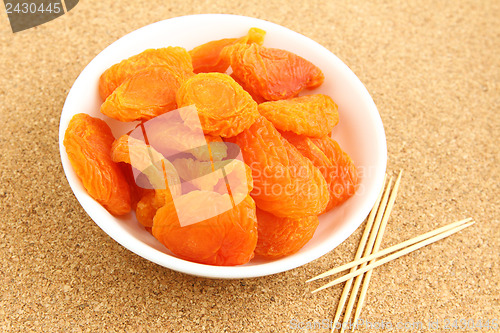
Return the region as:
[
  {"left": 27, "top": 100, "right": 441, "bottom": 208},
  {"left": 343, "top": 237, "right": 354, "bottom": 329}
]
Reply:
[{"left": 259, "top": 94, "right": 339, "bottom": 137}]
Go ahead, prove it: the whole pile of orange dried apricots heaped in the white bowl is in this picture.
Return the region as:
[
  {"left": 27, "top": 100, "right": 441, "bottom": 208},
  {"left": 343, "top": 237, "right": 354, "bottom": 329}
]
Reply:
[{"left": 64, "top": 28, "right": 358, "bottom": 265}]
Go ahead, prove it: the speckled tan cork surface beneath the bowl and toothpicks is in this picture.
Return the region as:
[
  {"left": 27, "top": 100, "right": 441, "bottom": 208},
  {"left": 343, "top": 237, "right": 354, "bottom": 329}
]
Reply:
[{"left": 0, "top": 0, "right": 500, "bottom": 332}]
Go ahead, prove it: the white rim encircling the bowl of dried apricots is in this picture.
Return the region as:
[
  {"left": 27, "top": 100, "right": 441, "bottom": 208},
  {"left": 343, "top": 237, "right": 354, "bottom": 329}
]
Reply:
[{"left": 59, "top": 14, "right": 387, "bottom": 279}]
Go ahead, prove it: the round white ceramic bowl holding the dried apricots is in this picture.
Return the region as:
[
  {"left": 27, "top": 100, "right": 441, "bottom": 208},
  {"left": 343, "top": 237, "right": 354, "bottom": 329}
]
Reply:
[{"left": 59, "top": 14, "right": 387, "bottom": 278}]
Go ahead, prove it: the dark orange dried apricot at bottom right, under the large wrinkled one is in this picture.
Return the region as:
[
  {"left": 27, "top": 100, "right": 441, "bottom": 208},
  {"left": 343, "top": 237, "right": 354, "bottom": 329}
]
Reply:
[{"left": 255, "top": 208, "right": 319, "bottom": 259}]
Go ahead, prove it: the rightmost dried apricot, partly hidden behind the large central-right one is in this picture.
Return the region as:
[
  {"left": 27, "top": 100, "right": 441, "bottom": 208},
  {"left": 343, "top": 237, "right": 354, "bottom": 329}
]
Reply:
[{"left": 283, "top": 132, "right": 358, "bottom": 212}]
